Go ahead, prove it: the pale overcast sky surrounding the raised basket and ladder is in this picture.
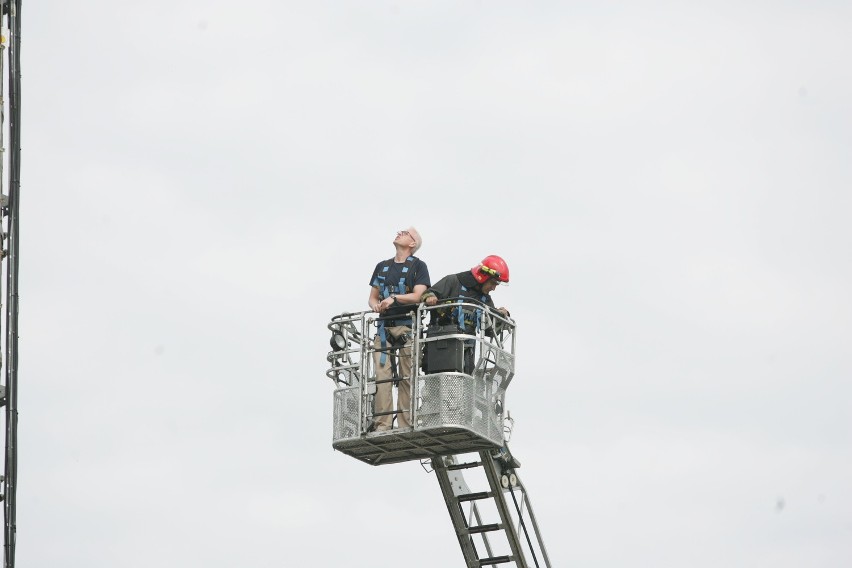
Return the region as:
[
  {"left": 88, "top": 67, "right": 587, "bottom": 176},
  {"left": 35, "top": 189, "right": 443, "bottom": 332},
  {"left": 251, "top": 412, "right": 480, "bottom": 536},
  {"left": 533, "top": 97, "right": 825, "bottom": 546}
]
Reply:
[{"left": 10, "top": 0, "right": 852, "bottom": 568}]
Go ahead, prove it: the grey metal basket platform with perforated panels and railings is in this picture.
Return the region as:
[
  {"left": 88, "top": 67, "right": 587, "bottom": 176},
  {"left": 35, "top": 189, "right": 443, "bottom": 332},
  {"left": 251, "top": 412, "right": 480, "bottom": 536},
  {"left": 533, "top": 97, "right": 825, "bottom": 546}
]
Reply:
[{"left": 329, "top": 306, "right": 515, "bottom": 465}]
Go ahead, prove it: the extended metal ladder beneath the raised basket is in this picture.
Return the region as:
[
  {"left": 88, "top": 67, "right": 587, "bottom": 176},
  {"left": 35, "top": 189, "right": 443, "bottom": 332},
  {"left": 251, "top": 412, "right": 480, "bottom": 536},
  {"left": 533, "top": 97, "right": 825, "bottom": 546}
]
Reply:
[{"left": 431, "top": 451, "right": 550, "bottom": 568}]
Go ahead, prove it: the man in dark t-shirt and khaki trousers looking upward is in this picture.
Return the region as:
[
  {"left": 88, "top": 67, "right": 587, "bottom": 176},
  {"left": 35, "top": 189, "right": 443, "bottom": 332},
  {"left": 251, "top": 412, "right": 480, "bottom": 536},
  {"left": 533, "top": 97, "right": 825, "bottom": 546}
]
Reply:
[{"left": 369, "top": 227, "right": 431, "bottom": 432}]
